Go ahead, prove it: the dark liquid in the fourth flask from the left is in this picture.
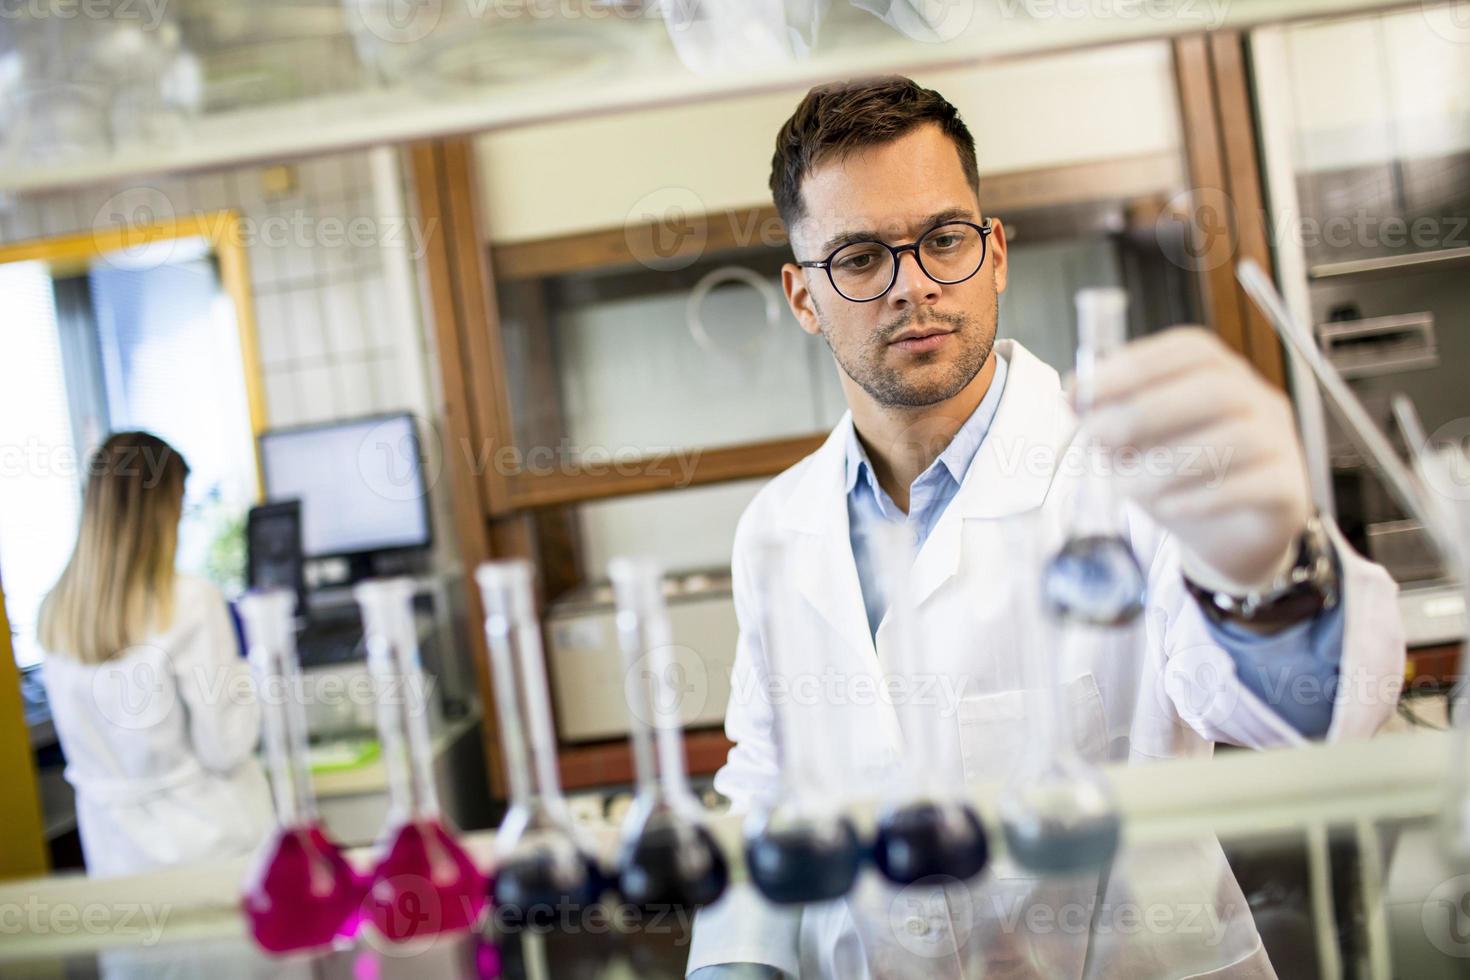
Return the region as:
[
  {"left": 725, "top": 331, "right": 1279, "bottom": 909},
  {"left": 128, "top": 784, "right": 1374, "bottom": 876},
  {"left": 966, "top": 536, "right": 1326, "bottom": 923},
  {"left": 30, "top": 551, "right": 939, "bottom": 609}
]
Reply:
[{"left": 617, "top": 814, "right": 731, "bottom": 908}]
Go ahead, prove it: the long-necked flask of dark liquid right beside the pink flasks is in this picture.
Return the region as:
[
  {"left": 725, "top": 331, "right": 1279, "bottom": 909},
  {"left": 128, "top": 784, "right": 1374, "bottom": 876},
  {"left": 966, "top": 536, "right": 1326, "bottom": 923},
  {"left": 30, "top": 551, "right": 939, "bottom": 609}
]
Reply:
[{"left": 475, "top": 558, "right": 606, "bottom": 920}]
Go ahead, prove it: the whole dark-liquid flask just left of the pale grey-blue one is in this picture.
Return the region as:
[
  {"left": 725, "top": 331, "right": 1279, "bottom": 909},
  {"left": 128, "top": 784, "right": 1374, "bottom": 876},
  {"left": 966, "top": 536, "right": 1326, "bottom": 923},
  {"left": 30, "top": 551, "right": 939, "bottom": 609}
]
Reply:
[{"left": 873, "top": 525, "right": 989, "bottom": 884}]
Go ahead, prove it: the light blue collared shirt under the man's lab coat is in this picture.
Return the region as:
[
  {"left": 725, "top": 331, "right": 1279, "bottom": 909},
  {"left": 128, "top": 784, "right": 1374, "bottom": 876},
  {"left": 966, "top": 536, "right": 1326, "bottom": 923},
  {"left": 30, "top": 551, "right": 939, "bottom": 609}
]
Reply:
[{"left": 847, "top": 351, "right": 1344, "bottom": 738}]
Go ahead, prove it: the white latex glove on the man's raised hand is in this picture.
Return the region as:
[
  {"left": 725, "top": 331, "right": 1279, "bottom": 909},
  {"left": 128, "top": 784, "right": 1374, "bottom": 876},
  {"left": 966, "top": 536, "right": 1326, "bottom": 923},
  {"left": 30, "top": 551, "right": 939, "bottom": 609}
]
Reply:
[{"left": 1082, "top": 326, "right": 1311, "bottom": 595}]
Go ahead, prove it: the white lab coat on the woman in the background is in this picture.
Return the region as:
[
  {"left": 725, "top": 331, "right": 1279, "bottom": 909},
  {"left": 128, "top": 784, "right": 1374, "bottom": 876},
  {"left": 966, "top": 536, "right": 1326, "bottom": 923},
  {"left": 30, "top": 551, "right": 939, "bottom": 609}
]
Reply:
[{"left": 44, "top": 574, "right": 272, "bottom": 876}]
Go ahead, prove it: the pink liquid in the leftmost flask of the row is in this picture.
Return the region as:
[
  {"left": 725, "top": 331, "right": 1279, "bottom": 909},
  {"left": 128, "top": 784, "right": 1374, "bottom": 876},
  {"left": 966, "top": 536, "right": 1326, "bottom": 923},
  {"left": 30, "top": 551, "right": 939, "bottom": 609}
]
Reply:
[{"left": 241, "top": 824, "right": 366, "bottom": 952}]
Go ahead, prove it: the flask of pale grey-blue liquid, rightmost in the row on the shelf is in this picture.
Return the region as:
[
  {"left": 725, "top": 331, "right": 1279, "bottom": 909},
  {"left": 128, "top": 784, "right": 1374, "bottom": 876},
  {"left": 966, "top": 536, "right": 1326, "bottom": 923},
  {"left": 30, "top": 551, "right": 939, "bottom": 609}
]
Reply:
[{"left": 998, "top": 514, "right": 1122, "bottom": 876}]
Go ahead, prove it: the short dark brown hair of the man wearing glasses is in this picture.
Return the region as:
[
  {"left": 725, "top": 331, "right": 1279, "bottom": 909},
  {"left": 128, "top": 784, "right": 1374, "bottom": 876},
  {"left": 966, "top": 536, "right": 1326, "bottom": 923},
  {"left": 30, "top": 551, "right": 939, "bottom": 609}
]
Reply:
[{"left": 770, "top": 75, "right": 980, "bottom": 232}]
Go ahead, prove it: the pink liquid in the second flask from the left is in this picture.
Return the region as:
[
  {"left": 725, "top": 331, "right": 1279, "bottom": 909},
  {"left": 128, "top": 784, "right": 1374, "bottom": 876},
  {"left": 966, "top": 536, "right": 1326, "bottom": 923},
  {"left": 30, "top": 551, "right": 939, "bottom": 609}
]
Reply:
[{"left": 368, "top": 820, "right": 485, "bottom": 942}]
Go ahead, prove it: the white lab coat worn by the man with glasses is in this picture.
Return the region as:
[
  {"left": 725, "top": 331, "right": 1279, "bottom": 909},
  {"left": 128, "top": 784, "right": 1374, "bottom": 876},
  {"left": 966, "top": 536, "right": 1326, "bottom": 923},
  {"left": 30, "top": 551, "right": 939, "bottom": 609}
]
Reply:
[{"left": 688, "top": 339, "right": 1404, "bottom": 980}]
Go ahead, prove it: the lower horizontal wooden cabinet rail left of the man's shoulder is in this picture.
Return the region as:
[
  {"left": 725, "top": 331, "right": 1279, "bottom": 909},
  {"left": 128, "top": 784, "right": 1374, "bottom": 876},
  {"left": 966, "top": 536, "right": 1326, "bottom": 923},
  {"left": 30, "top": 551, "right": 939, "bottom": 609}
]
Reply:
[{"left": 502, "top": 433, "right": 826, "bottom": 514}]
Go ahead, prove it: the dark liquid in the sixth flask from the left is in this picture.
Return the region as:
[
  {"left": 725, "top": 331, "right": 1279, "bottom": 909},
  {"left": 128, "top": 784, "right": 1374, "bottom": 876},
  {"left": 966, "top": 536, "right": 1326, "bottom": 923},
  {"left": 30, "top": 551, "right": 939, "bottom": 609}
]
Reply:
[{"left": 873, "top": 802, "right": 991, "bottom": 884}]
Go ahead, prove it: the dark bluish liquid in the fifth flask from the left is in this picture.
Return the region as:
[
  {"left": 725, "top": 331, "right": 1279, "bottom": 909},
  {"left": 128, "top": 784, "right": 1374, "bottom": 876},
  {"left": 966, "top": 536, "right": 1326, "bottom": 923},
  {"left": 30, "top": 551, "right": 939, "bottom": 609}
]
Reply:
[{"left": 745, "top": 818, "right": 863, "bottom": 905}]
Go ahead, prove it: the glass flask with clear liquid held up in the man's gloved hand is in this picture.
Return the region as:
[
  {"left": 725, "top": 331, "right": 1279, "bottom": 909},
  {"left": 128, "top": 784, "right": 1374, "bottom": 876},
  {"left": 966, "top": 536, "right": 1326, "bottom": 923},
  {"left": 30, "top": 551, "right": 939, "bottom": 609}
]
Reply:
[{"left": 1042, "top": 288, "right": 1147, "bottom": 626}]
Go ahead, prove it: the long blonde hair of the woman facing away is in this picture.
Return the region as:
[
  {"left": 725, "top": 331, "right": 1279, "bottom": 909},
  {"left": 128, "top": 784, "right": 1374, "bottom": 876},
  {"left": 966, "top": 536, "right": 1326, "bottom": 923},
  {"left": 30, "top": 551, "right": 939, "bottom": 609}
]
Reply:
[{"left": 38, "top": 432, "right": 188, "bottom": 664}]
